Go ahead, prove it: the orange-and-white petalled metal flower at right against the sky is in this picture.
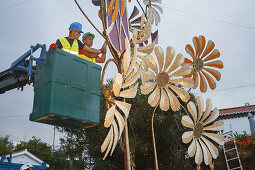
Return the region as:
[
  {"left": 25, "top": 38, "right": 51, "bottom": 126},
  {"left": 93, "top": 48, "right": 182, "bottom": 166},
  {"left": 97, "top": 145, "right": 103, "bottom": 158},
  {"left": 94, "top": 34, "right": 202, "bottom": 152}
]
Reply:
[{"left": 185, "top": 35, "right": 223, "bottom": 92}]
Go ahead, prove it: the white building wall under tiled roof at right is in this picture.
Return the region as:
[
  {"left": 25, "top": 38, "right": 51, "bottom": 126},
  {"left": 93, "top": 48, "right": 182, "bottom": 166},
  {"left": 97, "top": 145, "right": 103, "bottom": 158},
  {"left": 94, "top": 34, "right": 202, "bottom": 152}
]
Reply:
[{"left": 223, "top": 117, "right": 251, "bottom": 134}]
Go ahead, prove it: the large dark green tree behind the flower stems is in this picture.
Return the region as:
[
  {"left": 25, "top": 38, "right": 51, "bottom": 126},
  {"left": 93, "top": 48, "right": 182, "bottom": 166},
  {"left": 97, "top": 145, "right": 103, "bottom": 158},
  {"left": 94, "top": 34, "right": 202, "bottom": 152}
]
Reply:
[{"left": 57, "top": 81, "right": 197, "bottom": 169}]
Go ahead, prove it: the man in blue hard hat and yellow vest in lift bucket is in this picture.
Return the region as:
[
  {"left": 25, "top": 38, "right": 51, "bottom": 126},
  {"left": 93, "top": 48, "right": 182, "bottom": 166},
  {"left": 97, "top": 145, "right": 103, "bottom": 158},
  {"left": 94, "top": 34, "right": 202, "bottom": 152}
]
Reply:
[{"left": 56, "top": 22, "right": 102, "bottom": 56}]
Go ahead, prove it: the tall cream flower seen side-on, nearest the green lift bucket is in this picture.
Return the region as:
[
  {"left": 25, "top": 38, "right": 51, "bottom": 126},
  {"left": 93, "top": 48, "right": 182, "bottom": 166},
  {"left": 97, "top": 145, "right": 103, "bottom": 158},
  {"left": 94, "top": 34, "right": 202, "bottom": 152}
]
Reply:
[{"left": 101, "top": 39, "right": 139, "bottom": 159}]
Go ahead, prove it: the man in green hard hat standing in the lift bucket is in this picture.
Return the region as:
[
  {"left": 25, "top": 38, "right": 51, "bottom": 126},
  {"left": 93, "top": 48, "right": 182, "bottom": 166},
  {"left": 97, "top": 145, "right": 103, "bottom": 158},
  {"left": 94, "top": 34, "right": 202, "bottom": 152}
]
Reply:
[{"left": 79, "top": 32, "right": 107, "bottom": 63}]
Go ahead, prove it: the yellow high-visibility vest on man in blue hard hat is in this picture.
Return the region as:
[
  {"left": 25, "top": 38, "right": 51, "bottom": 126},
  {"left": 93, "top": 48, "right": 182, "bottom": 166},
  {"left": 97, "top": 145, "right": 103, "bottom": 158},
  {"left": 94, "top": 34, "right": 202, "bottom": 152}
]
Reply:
[{"left": 59, "top": 38, "right": 79, "bottom": 56}]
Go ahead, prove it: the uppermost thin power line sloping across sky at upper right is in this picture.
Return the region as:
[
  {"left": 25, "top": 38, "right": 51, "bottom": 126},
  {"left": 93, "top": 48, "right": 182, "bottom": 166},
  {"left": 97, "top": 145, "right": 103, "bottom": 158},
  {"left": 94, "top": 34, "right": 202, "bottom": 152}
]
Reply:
[{"left": 163, "top": 6, "right": 254, "bottom": 30}]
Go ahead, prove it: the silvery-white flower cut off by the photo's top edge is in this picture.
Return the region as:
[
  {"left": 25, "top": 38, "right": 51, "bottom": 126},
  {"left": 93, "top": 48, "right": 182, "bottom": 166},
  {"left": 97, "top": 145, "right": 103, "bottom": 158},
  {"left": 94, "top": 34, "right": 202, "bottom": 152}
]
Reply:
[{"left": 143, "top": 0, "right": 163, "bottom": 26}]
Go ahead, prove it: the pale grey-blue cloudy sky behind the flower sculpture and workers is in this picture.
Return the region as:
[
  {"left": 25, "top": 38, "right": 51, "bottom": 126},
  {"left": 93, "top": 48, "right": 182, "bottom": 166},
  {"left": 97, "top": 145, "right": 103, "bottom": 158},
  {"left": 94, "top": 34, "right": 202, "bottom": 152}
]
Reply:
[{"left": 0, "top": 0, "right": 255, "bottom": 144}]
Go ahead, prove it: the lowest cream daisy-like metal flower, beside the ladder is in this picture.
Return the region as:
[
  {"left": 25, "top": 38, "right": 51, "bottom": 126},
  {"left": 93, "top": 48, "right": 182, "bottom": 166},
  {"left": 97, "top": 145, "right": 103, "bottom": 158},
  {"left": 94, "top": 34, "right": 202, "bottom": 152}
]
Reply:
[{"left": 181, "top": 97, "right": 225, "bottom": 165}]
